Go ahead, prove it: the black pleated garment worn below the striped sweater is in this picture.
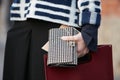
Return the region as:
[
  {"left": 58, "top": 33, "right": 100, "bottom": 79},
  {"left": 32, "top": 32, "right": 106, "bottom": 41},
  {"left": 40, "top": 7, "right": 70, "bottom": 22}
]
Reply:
[{"left": 3, "top": 19, "right": 60, "bottom": 80}]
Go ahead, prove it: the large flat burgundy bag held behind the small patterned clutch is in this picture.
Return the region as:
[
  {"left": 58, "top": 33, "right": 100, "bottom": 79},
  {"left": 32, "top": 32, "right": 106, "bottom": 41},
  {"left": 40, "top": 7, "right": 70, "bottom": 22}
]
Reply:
[{"left": 44, "top": 45, "right": 113, "bottom": 80}]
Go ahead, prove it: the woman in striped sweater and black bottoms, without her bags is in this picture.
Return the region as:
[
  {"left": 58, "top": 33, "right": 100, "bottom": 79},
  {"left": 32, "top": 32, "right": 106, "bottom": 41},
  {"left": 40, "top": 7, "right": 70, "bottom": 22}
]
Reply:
[{"left": 3, "top": 0, "right": 101, "bottom": 80}]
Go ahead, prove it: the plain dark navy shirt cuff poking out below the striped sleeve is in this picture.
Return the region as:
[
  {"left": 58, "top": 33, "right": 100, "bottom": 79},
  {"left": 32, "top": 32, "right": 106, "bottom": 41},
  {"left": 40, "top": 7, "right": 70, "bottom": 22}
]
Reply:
[{"left": 81, "top": 25, "right": 98, "bottom": 51}]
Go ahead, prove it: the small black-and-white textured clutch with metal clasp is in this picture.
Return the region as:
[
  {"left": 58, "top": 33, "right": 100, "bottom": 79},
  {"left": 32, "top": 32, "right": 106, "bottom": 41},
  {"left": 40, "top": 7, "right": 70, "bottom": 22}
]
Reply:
[{"left": 47, "top": 27, "right": 79, "bottom": 67}]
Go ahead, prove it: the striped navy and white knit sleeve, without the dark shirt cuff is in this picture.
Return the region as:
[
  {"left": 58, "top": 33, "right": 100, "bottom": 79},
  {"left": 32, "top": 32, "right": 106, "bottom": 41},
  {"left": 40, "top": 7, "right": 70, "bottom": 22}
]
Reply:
[{"left": 77, "top": 0, "right": 101, "bottom": 27}]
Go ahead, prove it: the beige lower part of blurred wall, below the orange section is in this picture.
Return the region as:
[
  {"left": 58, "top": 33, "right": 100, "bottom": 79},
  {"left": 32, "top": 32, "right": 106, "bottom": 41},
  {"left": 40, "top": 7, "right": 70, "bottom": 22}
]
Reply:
[{"left": 99, "top": 16, "right": 120, "bottom": 80}]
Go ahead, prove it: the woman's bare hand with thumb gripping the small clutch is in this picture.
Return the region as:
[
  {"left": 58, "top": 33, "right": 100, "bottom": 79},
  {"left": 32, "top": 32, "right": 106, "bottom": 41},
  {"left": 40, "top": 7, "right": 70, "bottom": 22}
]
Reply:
[{"left": 61, "top": 26, "right": 89, "bottom": 57}]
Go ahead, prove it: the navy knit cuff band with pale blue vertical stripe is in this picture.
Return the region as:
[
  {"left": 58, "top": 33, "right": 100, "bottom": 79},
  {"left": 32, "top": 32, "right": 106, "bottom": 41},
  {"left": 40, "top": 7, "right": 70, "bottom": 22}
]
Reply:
[{"left": 78, "top": 11, "right": 101, "bottom": 26}]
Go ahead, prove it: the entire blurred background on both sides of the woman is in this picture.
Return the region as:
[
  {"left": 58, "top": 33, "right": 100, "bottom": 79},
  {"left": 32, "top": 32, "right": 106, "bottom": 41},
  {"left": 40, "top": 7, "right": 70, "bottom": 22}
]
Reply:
[{"left": 0, "top": 0, "right": 120, "bottom": 80}]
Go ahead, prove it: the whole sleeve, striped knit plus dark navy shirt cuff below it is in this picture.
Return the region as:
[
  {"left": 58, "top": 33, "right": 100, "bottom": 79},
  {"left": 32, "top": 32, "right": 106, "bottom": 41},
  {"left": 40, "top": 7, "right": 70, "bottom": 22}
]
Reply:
[{"left": 78, "top": 0, "right": 101, "bottom": 51}]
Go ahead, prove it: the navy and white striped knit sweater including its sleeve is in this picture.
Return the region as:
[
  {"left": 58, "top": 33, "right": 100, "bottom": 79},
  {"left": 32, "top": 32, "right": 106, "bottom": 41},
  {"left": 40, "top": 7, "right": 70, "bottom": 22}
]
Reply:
[{"left": 10, "top": 0, "right": 101, "bottom": 27}]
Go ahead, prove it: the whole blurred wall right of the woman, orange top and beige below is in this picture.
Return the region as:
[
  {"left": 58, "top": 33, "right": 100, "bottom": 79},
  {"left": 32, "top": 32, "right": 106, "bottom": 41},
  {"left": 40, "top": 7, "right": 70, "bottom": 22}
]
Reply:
[{"left": 99, "top": 0, "right": 120, "bottom": 80}]
